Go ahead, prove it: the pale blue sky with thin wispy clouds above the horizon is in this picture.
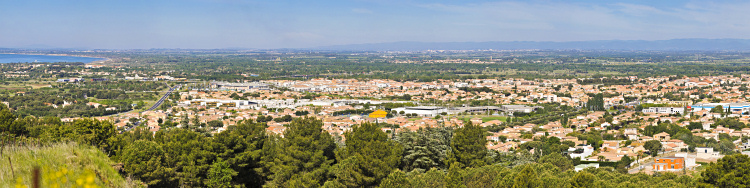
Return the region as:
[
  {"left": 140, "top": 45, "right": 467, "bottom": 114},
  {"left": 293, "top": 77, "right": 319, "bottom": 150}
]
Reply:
[{"left": 0, "top": 0, "right": 750, "bottom": 49}]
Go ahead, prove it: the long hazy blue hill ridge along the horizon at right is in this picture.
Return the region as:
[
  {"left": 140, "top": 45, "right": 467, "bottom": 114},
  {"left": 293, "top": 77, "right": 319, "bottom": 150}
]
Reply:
[{"left": 311, "top": 39, "right": 750, "bottom": 51}]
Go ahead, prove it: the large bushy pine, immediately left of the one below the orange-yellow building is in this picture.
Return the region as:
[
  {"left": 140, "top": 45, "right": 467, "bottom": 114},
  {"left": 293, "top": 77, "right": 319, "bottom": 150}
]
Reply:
[{"left": 264, "top": 117, "right": 336, "bottom": 187}]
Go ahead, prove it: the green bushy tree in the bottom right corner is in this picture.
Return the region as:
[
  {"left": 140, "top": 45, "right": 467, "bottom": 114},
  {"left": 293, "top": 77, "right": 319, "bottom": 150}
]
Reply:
[{"left": 698, "top": 154, "right": 750, "bottom": 187}]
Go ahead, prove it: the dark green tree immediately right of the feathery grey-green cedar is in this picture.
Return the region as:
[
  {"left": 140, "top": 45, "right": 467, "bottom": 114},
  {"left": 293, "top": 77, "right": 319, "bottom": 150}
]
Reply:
[{"left": 448, "top": 122, "right": 487, "bottom": 167}]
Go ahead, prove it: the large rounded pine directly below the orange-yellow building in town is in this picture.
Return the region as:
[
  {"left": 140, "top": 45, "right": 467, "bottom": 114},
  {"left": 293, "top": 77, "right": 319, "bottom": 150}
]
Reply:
[{"left": 332, "top": 123, "right": 403, "bottom": 187}]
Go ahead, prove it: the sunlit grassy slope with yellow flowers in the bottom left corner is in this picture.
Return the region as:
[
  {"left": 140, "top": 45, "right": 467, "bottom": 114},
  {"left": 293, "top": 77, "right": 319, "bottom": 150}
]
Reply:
[{"left": 0, "top": 143, "right": 139, "bottom": 187}]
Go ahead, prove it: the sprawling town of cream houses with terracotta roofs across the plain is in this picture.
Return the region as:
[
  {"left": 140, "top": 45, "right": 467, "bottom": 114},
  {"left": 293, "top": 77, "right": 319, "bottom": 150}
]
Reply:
[{"left": 63, "top": 72, "right": 750, "bottom": 174}]
